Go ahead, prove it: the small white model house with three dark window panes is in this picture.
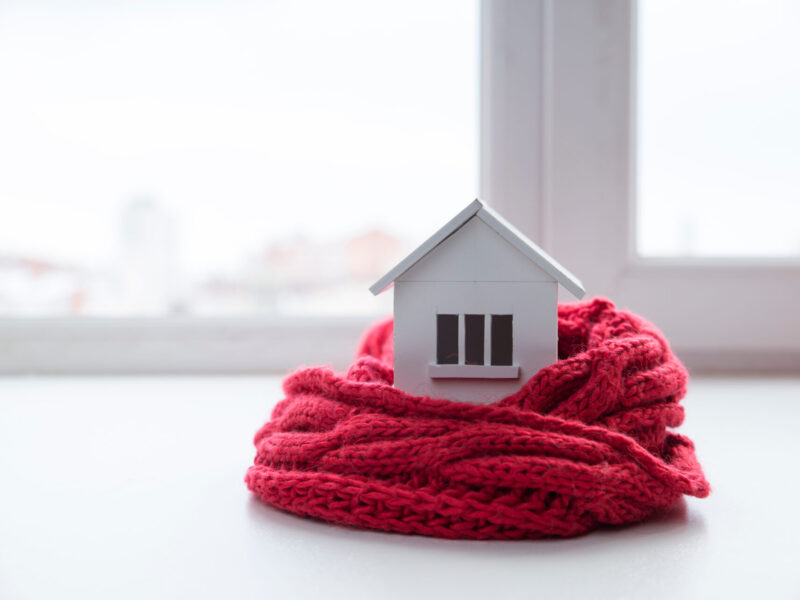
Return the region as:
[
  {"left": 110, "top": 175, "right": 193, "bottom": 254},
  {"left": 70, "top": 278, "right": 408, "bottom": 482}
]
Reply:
[{"left": 370, "top": 200, "right": 585, "bottom": 402}]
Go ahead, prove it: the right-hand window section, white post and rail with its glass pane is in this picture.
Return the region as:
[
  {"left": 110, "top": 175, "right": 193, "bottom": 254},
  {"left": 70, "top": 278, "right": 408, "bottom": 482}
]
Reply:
[{"left": 482, "top": 0, "right": 800, "bottom": 373}]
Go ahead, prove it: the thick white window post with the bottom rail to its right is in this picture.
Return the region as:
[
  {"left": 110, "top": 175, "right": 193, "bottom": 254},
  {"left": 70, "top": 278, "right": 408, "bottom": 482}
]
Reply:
[{"left": 481, "top": 0, "right": 800, "bottom": 372}]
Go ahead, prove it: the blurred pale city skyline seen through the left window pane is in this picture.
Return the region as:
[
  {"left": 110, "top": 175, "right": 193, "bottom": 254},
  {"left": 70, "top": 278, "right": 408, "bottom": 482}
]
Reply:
[{"left": 0, "top": 198, "right": 410, "bottom": 316}]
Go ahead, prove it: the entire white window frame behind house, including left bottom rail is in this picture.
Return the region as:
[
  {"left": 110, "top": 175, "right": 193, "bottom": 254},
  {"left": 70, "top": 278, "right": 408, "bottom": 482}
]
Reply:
[{"left": 0, "top": 0, "right": 800, "bottom": 373}]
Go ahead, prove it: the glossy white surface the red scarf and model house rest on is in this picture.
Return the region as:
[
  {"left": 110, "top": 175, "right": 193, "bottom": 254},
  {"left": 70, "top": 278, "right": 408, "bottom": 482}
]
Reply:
[{"left": 0, "top": 377, "right": 800, "bottom": 600}]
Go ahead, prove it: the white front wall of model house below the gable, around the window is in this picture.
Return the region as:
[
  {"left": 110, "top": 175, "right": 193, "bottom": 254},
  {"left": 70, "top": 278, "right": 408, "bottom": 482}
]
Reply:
[{"left": 394, "top": 280, "right": 558, "bottom": 402}]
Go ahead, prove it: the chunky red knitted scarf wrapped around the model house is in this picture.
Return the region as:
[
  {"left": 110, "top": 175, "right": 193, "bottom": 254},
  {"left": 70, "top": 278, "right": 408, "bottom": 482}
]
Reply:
[{"left": 245, "top": 299, "right": 709, "bottom": 539}]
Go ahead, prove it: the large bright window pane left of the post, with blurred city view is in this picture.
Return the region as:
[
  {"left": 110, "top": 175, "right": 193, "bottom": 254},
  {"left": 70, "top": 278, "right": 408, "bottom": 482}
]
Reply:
[{"left": 0, "top": 0, "right": 478, "bottom": 315}]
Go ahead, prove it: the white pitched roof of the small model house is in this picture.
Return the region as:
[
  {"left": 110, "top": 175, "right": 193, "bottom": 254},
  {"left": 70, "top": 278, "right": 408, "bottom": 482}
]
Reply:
[{"left": 369, "top": 200, "right": 586, "bottom": 298}]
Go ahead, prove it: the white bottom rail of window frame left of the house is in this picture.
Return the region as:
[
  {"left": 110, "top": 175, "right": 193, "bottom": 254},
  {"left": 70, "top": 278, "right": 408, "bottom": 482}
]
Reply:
[{"left": 0, "top": 314, "right": 372, "bottom": 374}]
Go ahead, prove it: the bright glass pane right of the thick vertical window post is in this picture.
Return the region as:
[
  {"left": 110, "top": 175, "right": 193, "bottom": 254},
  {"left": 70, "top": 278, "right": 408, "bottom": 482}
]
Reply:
[{"left": 637, "top": 0, "right": 800, "bottom": 256}]
